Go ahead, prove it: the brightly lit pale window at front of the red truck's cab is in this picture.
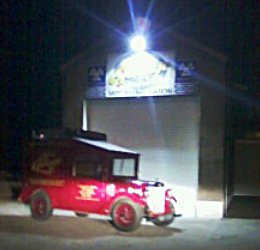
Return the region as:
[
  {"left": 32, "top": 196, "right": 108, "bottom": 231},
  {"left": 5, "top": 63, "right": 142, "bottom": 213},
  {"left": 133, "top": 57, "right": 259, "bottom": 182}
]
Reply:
[{"left": 113, "top": 158, "right": 135, "bottom": 177}]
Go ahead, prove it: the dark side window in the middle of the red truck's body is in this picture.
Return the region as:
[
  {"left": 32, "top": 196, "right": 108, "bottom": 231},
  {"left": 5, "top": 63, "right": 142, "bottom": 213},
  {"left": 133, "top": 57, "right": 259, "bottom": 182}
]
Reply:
[{"left": 73, "top": 158, "right": 103, "bottom": 179}]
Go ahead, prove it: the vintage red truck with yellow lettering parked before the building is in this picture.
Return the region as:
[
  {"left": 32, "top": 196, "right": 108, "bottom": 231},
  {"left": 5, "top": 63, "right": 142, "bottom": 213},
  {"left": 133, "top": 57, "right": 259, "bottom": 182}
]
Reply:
[{"left": 19, "top": 132, "right": 176, "bottom": 231}]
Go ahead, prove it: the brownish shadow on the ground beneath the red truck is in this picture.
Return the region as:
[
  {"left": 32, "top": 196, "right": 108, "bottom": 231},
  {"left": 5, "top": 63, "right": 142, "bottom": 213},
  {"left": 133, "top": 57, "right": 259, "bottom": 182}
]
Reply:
[{"left": 0, "top": 216, "right": 182, "bottom": 240}]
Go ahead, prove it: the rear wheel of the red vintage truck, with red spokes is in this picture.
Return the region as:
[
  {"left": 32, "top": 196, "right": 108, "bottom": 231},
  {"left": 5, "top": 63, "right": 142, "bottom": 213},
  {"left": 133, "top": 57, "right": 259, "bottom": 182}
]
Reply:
[{"left": 30, "top": 191, "right": 52, "bottom": 220}]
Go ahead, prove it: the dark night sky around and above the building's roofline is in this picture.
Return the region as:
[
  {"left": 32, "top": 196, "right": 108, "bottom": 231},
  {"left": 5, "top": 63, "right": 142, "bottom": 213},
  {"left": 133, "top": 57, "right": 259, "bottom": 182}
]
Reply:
[{"left": 0, "top": 0, "right": 260, "bottom": 176}]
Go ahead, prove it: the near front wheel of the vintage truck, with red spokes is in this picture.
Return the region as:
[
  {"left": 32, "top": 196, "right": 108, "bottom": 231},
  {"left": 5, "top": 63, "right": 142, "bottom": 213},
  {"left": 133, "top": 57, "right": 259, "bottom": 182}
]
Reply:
[{"left": 112, "top": 199, "right": 143, "bottom": 232}]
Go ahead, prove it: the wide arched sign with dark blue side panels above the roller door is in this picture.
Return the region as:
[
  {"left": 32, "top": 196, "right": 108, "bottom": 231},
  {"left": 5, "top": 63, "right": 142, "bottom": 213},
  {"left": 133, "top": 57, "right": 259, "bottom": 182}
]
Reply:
[{"left": 86, "top": 52, "right": 198, "bottom": 99}]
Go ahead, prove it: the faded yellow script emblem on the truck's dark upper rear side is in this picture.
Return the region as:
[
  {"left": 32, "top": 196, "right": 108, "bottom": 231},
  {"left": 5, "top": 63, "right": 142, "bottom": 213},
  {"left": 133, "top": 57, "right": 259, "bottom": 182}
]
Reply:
[{"left": 32, "top": 152, "right": 61, "bottom": 175}]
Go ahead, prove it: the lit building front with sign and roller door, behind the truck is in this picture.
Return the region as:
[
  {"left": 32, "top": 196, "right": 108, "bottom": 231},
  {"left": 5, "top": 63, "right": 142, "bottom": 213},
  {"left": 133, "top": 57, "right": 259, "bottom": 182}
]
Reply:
[{"left": 62, "top": 32, "right": 225, "bottom": 217}]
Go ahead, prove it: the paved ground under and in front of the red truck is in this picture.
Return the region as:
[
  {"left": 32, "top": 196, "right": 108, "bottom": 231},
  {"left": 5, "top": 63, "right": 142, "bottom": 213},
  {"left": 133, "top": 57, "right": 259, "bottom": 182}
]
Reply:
[{"left": 0, "top": 201, "right": 260, "bottom": 250}]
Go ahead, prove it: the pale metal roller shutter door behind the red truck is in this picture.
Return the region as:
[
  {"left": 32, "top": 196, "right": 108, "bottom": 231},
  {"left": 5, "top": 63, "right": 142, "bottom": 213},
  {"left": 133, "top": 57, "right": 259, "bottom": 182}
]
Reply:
[{"left": 88, "top": 97, "right": 200, "bottom": 216}]
